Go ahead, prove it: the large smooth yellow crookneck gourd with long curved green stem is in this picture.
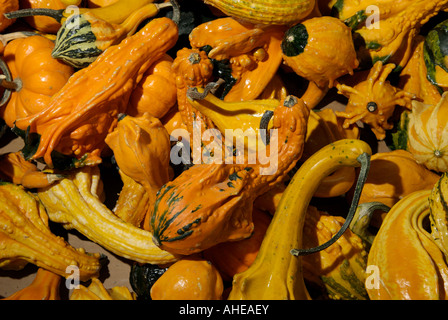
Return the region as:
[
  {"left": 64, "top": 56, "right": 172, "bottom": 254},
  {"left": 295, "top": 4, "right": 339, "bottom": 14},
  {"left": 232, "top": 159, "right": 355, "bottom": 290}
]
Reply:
[{"left": 229, "top": 139, "right": 371, "bottom": 300}]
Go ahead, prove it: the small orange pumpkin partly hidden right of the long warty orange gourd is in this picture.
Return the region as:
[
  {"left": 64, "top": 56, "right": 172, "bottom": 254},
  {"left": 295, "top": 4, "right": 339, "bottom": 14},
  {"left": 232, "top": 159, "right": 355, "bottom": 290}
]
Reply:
[{"left": 126, "top": 54, "right": 177, "bottom": 119}]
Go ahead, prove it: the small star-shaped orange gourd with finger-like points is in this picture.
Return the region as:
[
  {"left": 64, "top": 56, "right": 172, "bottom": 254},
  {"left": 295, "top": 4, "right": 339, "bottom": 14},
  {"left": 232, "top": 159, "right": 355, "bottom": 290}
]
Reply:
[{"left": 336, "top": 61, "right": 415, "bottom": 140}]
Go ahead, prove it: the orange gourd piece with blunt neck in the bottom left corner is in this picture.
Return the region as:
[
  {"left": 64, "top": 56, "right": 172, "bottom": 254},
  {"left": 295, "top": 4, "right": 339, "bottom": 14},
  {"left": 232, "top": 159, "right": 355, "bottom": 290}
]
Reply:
[{"left": 2, "top": 268, "right": 62, "bottom": 300}]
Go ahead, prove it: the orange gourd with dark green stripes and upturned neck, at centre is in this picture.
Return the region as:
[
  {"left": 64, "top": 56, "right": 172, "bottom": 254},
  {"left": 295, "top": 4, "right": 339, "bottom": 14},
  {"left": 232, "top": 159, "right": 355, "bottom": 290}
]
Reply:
[{"left": 150, "top": 96, "right": 309, "bottom": 254}]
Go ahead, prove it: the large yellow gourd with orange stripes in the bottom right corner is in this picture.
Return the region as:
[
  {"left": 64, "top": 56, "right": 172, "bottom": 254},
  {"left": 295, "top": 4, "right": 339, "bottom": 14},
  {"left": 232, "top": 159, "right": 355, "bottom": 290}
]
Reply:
[{"left": 366, "top": 190, "right": 448, "bottom": 300}]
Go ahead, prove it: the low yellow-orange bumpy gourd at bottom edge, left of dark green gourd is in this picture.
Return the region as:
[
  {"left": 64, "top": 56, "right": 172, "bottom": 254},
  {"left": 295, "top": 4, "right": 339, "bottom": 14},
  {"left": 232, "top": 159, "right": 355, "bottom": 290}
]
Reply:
[{"left": 70, "top": 278, "right": 136, "bottom": 300}]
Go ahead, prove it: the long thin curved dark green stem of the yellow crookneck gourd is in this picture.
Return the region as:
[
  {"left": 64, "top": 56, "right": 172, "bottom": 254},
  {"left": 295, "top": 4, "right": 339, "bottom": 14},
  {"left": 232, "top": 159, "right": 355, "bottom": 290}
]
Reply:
[{"left": 291, "top": 152, "right": 370, "bottom": 256}]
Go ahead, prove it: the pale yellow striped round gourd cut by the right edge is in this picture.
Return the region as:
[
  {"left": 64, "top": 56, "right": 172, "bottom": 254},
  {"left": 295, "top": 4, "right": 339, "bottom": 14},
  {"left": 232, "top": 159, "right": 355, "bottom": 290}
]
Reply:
[{"left": 407, "top": 93, "right": 448, "bottom": 172}]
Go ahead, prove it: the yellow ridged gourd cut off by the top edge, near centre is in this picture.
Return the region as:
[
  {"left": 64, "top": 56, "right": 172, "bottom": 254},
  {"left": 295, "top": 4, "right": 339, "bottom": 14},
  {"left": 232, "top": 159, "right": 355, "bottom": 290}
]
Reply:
[{"left": 204, "top": 0, "right": 316, "bottom": 25}]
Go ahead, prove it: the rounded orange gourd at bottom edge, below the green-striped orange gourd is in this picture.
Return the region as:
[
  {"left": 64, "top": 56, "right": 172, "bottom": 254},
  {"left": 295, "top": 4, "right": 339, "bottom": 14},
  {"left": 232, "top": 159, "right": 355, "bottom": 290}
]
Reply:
[{"left": 151, "top": 258, "right": 224, "bottom": 300}]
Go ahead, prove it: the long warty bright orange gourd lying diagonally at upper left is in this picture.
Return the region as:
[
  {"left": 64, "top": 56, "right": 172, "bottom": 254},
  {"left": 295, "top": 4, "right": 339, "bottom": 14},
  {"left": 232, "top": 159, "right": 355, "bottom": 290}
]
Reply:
[{"left": 11, "top": 18, "right": 178, "bottom": 167}]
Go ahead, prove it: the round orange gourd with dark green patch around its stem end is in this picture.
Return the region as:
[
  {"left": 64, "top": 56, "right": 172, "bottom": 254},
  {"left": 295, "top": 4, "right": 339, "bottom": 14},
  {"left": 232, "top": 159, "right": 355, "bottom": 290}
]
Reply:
[{"left": 281, "top": 16, "right": 358, "bottom": 88}]
